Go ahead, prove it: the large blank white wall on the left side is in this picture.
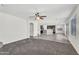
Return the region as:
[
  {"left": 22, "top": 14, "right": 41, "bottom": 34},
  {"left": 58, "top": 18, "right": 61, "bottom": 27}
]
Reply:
[{"left": 0, "top": 12, "right": 28, "bottom": 44}]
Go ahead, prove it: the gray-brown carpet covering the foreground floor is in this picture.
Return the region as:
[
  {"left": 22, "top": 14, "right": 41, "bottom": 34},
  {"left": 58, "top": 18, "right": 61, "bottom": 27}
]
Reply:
[{"left": 0, "top": 39, "right": 77, "bottom": 55}]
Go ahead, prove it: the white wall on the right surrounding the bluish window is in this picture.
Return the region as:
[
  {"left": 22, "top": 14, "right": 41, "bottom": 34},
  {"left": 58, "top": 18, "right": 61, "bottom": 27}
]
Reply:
[{"left": 68, "top": 6, "right": 79, "bottom": 54}]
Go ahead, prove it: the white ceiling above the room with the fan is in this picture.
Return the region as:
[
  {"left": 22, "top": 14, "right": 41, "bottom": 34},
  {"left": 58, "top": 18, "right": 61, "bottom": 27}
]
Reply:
[{"left": 0, "top": 4, "right": 75, "bottom": 19}]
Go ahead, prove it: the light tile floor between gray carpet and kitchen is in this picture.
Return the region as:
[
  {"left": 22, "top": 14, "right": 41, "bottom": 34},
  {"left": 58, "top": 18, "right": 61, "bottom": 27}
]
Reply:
[{"left": 34, "top": 34, "right": 69, "bottom": 44}]
